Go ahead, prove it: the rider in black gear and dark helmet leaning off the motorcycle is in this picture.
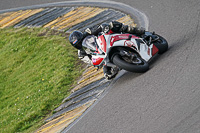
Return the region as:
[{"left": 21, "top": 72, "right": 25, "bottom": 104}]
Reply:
[{"left": 69, "top": 21, "right": 145, "bottom": 79}]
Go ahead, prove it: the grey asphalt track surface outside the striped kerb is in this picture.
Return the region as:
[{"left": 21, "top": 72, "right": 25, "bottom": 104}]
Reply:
[{"left": 0, "top": 0, "right": 200, "bottom": 133}]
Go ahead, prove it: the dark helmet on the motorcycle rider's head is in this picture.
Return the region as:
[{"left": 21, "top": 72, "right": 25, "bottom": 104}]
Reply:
[{"left": 69, "top": 31, "right": 83, "bottom": 49}]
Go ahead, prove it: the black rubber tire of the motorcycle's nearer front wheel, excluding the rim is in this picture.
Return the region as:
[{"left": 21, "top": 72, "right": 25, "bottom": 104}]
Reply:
[{"left": 113, "top": 54, "right": 149, "bottom": 73}]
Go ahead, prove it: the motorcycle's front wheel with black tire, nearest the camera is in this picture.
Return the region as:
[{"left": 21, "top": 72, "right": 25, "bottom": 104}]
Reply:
[{"left": 113, "top": 54, "right": 149, "bottom": 73}]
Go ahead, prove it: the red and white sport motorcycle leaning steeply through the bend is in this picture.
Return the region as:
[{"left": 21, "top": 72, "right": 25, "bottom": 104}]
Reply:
[{"left": 82, "top": 28, "right": 168, "bottom": 78}]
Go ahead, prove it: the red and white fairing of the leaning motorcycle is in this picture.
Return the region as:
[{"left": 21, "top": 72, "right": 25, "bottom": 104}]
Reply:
[{"left": 83, "top": 34, "right": 158, "bottom": 66}]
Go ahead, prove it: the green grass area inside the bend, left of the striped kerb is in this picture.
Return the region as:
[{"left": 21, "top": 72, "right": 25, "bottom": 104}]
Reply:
[{"left": 0, "top": 28, "right": 83, "bottom": 133}]
